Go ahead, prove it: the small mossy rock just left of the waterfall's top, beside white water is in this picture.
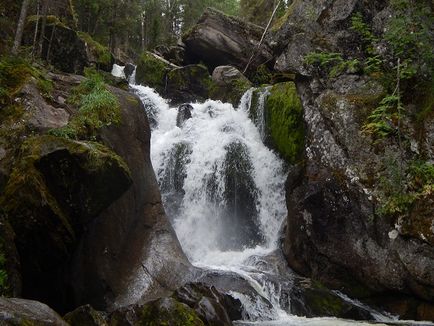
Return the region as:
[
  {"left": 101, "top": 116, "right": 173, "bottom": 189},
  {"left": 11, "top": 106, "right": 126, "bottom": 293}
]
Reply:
[{"left": 136, "top": 52, "right": 171, "bottom": 93}]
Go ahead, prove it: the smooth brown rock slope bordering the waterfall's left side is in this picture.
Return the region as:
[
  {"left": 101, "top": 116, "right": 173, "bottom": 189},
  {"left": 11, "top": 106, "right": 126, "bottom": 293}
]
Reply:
[{"left": 71, "top": 85, "right": 190, "bottom": 309}]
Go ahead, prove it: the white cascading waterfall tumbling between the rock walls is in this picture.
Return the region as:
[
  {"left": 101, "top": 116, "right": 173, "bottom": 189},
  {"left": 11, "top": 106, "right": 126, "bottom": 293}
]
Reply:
[{"left": 131, "top": 81, "right": 430, "bottom": 325}]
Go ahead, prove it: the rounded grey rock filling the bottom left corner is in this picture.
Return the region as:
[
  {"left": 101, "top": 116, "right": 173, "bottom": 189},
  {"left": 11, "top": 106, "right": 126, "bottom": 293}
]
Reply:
[{"left": 0, "top": 297, "right": 68, "bottom": 326}]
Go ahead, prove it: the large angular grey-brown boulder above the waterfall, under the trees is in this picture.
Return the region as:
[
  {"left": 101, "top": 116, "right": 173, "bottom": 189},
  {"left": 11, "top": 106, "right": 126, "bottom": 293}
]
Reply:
[{"left": 182, "top": 8, "right": 273, "bottom": 71}]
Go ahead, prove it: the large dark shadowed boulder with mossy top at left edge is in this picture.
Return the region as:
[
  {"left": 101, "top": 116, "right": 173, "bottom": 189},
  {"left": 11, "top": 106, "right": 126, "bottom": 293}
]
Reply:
[{"left": 0, "top": 136, "right": 131, "bottom": 302}]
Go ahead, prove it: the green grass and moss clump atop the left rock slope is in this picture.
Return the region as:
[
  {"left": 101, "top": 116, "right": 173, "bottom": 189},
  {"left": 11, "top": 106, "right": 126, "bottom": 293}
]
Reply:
[{"left": 50, "top": 70, "right": 121, "bottom": 139}]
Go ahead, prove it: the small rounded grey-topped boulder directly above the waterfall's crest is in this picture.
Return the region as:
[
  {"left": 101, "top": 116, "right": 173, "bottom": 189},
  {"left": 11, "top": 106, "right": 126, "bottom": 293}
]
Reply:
[{"left": 210, "top": 66, "right": 252, "bottom": 106}]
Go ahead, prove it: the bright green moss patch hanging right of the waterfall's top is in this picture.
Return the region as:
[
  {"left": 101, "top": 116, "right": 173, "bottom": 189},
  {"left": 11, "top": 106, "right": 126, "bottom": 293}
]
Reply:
[{"left": 266, "top": 82, "right": 304, "bottom": 164}]
